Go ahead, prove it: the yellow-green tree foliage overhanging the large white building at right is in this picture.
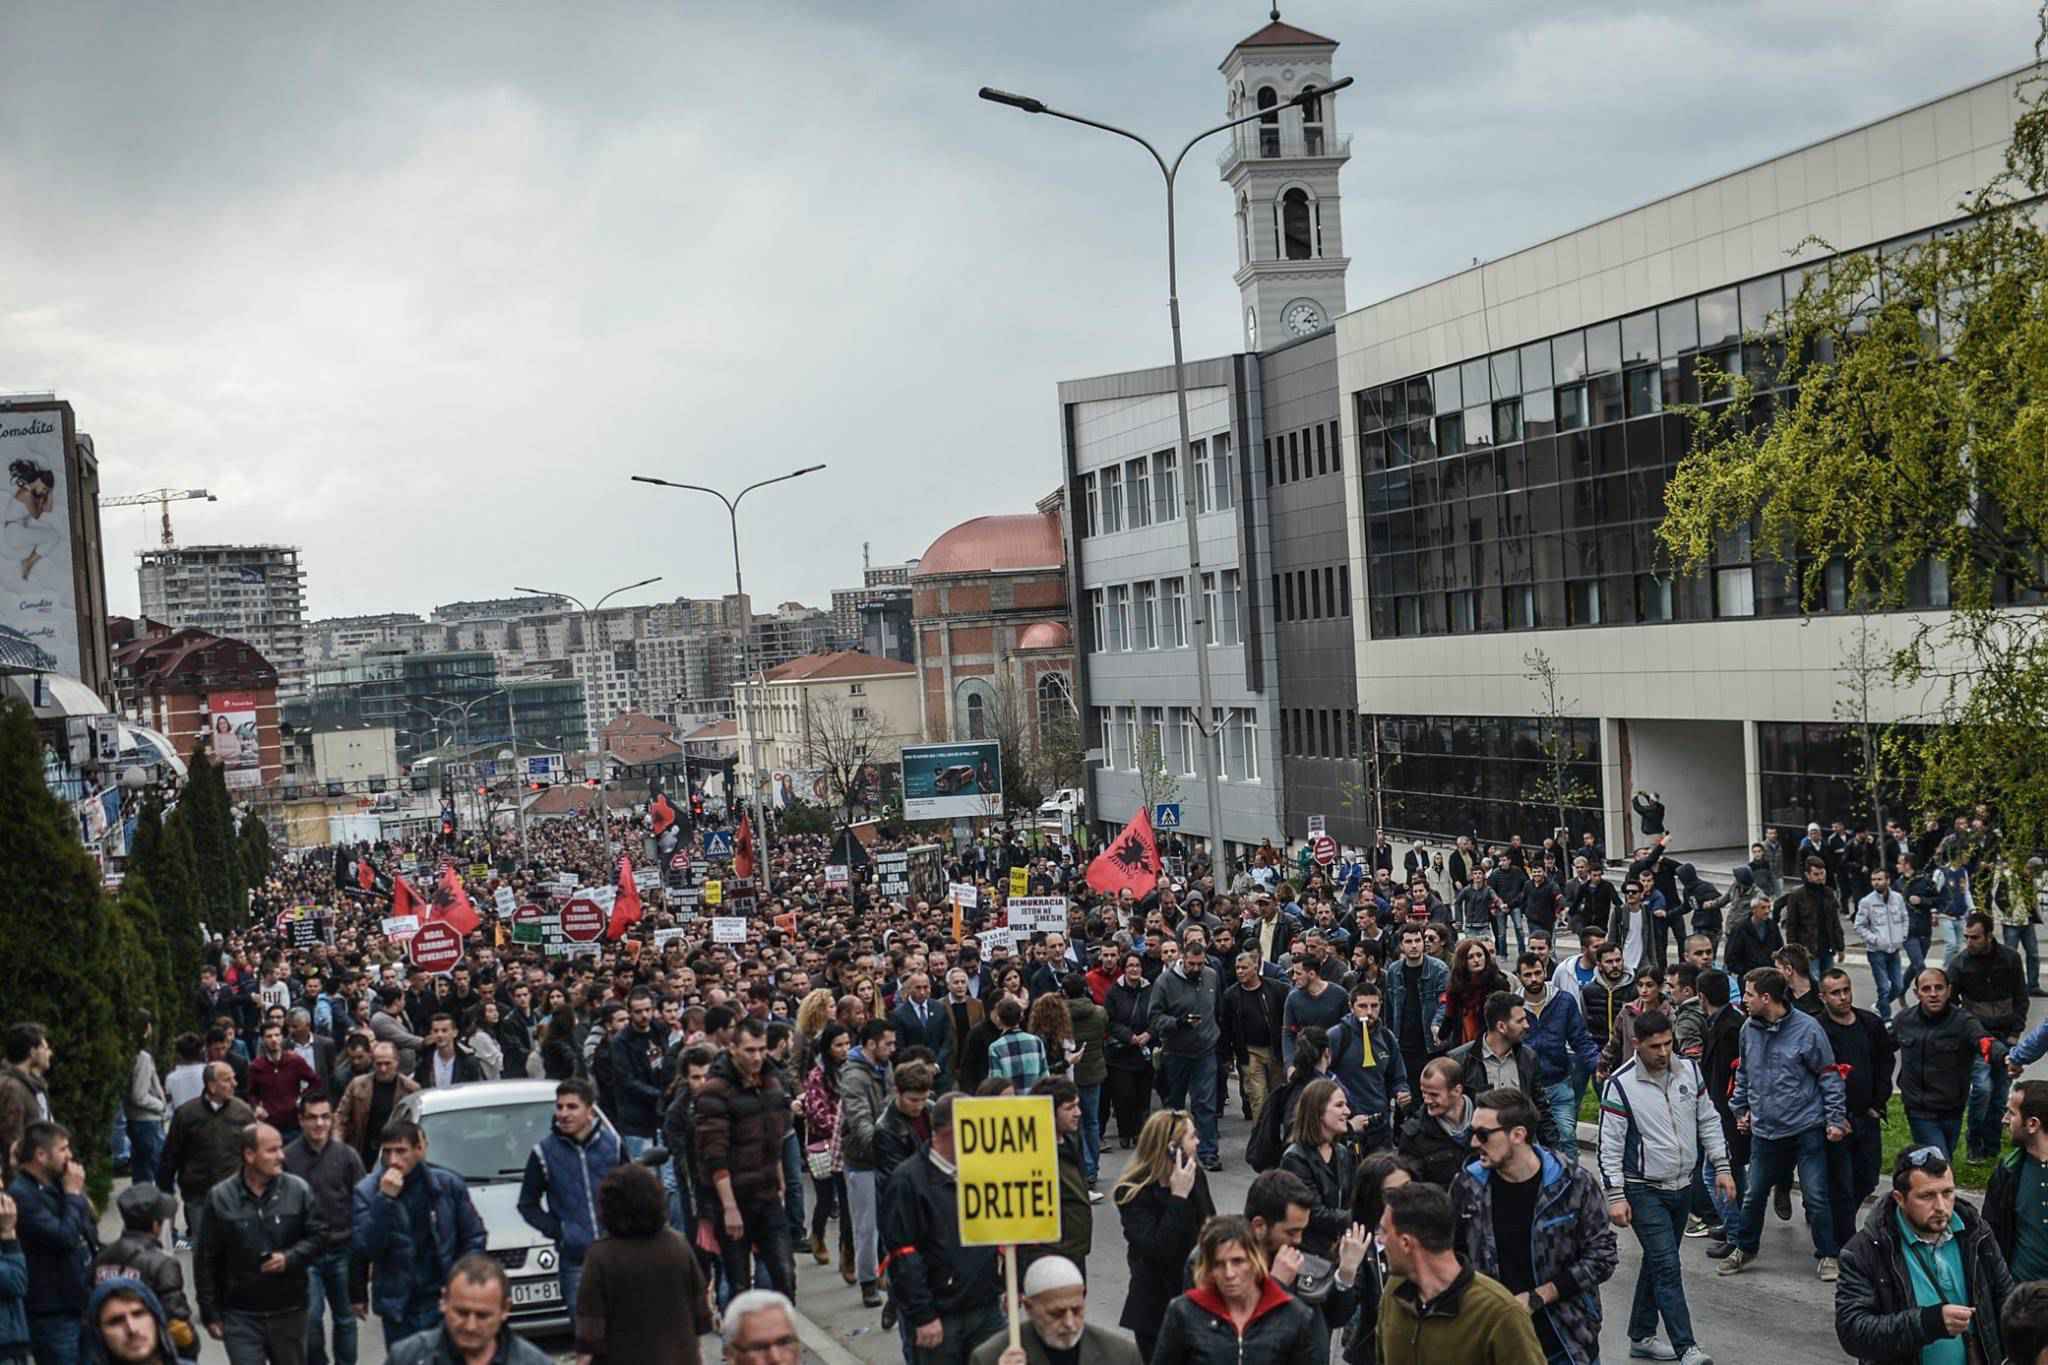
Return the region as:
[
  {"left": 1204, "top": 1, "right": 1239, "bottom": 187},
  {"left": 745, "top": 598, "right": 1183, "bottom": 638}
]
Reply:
[{"left": 1657, "top": 51, "right": 2048, "bottom": 875}]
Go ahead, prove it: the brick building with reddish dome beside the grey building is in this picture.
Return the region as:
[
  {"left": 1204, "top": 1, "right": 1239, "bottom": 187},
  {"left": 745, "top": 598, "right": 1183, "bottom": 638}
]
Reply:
[{"left": 909, "top": 493, "right": 1073, "bottom": 759}]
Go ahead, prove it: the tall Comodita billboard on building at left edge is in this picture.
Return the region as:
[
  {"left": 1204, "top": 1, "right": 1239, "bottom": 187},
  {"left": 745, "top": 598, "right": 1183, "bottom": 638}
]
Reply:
[{"left": 0, "top": 407, "right": 80, "bottom": 677}]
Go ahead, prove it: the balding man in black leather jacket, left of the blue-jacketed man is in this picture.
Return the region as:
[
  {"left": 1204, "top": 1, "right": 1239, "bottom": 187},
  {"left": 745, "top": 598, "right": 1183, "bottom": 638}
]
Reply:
[{"left": 193, "top": 1124, "right": 328, "bottom": 1361}]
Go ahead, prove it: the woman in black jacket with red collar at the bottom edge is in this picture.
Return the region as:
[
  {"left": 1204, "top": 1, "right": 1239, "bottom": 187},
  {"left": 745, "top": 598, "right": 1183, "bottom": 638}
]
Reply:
[{"left": 1153, "top": 1214, "right": 1329, "bottom": 1365}]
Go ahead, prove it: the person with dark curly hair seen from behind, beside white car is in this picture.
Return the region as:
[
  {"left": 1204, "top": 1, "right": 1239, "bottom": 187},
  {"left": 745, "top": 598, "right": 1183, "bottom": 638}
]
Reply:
[{"left": 575, "top": 1162, "right": 713, "bottom": 1365}]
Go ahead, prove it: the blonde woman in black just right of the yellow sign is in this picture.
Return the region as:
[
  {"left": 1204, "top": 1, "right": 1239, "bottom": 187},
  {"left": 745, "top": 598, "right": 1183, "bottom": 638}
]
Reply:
[{"left": 1110, "top": 1109, "right": 1217, "bottom": 1361}]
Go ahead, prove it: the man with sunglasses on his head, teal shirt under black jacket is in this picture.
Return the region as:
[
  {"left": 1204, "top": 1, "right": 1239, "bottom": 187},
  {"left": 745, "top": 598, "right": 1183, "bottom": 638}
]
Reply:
[{"left": 1835, "top": 1144, "right": 2013, "bottom": 1365}]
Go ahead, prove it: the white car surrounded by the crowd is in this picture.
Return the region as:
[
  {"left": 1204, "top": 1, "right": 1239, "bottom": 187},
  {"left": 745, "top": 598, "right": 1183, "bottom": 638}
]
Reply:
[{"left": 391, "top": 1081, "right": 608, "bottom": 1334}]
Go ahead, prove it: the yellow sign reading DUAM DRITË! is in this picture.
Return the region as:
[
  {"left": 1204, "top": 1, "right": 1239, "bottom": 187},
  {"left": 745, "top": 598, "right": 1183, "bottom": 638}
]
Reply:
[{"left": 952, "top": 1095, "right": 1059, "bottom": 1246}]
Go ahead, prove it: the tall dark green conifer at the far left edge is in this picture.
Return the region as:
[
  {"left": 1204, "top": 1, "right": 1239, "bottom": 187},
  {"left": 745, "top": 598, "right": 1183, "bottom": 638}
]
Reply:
[{"left": 0, "top": 700, "right": 135, "bottom": 1166}]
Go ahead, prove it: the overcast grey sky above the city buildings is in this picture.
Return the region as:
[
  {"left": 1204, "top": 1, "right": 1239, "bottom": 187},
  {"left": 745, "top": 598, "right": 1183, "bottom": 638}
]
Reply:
[{"left": 0, "top": 0, "right": 2034, "bottom": 616}]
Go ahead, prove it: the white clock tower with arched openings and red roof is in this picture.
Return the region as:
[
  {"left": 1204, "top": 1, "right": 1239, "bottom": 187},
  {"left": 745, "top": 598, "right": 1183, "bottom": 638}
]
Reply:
[{"left": 1223, "top": 10, "right": 1352, "bottom": 350}]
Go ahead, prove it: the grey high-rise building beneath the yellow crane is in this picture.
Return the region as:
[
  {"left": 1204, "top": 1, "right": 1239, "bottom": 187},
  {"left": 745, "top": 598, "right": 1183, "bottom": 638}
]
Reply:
[{"left": 135, "top": 544, "right": 305, "bottom": 700}]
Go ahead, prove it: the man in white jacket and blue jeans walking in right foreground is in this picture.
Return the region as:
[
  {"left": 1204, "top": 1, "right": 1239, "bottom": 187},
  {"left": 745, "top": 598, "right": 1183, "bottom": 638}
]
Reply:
[{"left": 1599, "top": 1009, "right": 1735, "bottom": 1365}]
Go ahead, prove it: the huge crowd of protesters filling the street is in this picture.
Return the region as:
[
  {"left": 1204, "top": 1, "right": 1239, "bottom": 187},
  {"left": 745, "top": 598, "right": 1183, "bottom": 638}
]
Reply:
[{"left": 12, "top": 802, "right": 2048, "bottom": 1365}]
